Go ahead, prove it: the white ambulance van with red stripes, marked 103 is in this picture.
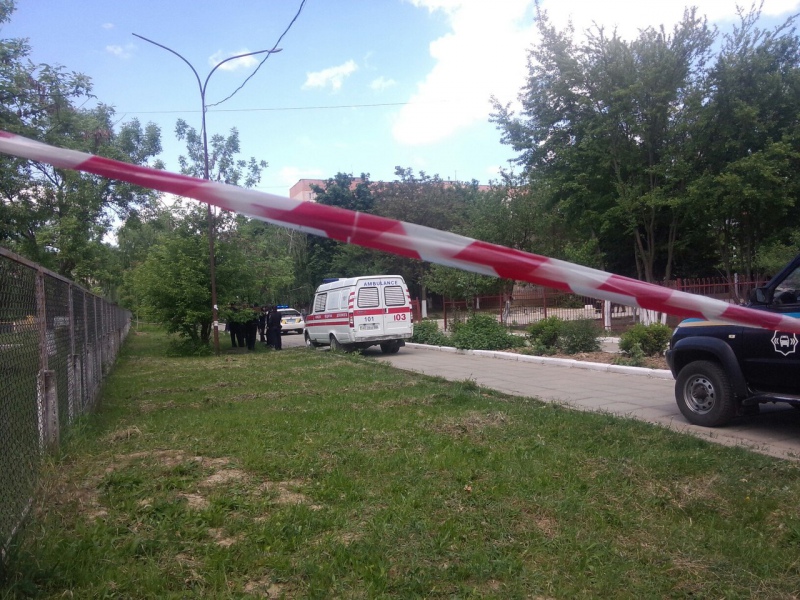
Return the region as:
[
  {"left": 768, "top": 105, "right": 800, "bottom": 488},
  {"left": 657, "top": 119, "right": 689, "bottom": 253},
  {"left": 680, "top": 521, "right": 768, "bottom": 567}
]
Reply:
[{"left": 305, "top": 275, "right": 414, "bottom": 354}]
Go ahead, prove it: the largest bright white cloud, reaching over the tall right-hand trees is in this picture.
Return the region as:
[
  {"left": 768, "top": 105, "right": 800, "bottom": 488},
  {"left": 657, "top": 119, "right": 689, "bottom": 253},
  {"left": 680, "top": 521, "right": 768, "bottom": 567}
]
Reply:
[{"left": 393, "top": 0, "right": 800, "bottom": 145}]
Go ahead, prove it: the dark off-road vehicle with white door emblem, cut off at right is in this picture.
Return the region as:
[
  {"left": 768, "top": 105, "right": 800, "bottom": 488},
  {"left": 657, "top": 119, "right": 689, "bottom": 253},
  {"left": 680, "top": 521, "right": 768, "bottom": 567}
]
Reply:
[{"left": 667, "top": 255, "right": 800, "bottom": 427}]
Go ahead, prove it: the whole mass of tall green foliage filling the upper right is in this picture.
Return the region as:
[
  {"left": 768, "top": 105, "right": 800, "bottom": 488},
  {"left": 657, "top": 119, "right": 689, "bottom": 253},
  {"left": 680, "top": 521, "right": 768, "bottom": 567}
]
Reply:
[{"left": 493, "top": 3, "right": 800, "bottom": 281}]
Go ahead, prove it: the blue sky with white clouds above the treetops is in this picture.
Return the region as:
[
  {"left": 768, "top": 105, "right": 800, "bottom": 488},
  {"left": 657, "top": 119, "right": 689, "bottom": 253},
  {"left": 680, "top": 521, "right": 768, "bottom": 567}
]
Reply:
[{"left": 2, "top": 0, "right": 800, "bottom": 195}]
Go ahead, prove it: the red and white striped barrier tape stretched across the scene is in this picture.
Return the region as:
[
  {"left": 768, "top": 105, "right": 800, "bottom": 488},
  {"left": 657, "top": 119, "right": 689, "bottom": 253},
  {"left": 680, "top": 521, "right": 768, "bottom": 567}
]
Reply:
[{"left": 0, "top": 131, "right": 800, "bottom": 333}]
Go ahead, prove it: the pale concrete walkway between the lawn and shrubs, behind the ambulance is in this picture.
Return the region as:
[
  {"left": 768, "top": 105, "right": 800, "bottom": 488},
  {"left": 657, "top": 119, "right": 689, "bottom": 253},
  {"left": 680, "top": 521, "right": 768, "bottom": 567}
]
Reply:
[{"left": 365, "top": 344, "right": 800, "bottom": 460}]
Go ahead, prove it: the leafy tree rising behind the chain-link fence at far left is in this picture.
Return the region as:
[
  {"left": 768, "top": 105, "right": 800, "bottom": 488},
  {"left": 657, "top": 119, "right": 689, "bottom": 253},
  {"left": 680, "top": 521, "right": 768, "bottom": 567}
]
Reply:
[{"left": 0, "top": 1, "right": 161, "bottom": 287}]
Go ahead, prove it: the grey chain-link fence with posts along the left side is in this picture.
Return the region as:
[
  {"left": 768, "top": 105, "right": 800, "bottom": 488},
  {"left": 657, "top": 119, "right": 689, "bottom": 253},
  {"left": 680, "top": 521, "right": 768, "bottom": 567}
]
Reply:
[{"left": 0, "top": 248, "right": 130, "bottom": 556}]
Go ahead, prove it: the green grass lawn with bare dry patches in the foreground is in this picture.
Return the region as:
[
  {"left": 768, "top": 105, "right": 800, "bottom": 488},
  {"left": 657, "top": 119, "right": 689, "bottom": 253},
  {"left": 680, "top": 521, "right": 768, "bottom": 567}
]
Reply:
[{"left": 0, "top": 330, "right": 800, "bottom": 599}]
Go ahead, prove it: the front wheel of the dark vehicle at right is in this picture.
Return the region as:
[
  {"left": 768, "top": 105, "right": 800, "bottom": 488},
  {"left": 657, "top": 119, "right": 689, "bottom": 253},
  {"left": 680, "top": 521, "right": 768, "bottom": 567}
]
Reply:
[{"left": 675, "top": 360, "right": 736, "bottom": 427}]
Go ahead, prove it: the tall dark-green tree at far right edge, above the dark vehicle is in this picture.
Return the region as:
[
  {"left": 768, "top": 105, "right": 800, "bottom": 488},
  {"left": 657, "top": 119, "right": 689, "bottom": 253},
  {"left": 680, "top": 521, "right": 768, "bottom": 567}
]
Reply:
[{"left": 691, "top": 9, "right": 800, "bottom": 277}]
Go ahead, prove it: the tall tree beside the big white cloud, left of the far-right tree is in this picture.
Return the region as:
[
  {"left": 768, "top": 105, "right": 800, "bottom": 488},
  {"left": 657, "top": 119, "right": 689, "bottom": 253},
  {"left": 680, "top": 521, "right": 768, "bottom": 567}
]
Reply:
[{"left": 492, "top": 7, "right": 714, "bottom": 281}]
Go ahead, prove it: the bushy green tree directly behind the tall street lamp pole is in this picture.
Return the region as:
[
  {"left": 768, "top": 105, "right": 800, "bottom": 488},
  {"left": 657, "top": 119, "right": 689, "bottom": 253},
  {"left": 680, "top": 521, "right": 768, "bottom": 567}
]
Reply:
[{"left": 122, "top": 121, "right": 274, "bottom": 345}]
